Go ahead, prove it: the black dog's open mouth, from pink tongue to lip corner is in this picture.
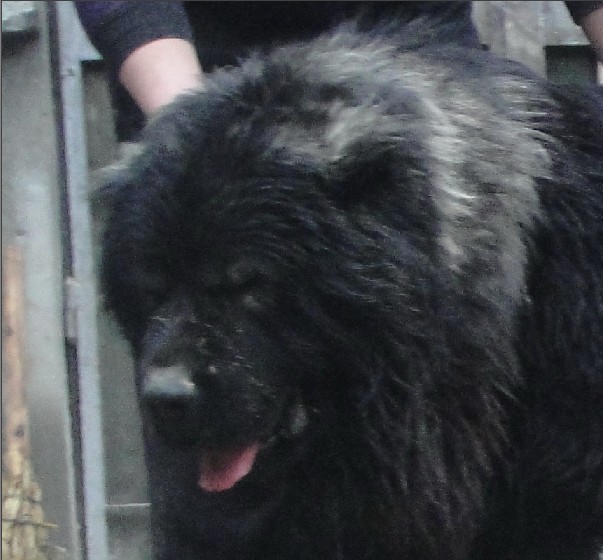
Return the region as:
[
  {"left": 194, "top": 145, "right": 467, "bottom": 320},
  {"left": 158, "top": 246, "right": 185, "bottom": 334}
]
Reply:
[{"left": 197, "top": 403, "right": 308, "bottom": 492}]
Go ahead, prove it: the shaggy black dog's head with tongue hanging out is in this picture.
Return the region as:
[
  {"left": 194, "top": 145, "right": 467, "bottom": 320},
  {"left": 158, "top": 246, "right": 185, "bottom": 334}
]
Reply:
[{"left": 103, "top": 44, "right": 436, "bottom": 490}]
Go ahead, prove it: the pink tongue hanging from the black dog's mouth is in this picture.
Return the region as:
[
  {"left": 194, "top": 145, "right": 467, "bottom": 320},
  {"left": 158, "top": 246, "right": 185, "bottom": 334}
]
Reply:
[{"left": 197, "top": 443, "right": 260, "bottom": 492}]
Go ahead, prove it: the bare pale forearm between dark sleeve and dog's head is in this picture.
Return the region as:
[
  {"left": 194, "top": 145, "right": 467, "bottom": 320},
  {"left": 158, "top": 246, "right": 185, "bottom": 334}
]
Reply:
[{"left": 119, "top": 38, "right": 203, "bottom": 116}]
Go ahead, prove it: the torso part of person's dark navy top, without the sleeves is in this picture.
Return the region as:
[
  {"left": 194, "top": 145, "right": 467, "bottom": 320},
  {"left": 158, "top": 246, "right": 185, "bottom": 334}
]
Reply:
[{"left": 184, "top": 1, "right": 479, "bottom": 70}]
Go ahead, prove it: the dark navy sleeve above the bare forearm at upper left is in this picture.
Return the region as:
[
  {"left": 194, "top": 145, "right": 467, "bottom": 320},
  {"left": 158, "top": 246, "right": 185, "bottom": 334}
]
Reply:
[{"left": 75, "top": 0, "right": 192, "bottom": 73}]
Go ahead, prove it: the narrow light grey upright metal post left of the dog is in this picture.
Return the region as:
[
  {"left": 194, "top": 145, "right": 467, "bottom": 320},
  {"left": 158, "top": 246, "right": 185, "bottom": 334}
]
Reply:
[{"left": 53, "top": 2, "right": 109, "bottom": 560}]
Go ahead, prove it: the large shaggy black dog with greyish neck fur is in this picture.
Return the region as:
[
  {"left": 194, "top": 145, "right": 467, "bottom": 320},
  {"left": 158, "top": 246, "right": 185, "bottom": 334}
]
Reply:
[{"left": 103, "top": 24, "right": 603, "bottom": 560}]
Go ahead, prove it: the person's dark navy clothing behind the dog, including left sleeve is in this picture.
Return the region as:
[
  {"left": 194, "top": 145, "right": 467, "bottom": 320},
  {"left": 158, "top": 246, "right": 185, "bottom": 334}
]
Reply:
[{"left": 75, "top": 0, "right": 480, "bottom": 140}]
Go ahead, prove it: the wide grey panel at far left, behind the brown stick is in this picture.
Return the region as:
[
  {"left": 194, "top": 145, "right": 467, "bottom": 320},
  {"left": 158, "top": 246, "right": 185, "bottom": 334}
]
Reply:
[{"left": 2, "top": 2, "right": 83, "bottom": 560}]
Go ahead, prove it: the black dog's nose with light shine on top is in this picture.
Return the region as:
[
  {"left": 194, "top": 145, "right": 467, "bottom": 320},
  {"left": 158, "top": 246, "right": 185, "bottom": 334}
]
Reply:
[{"left": 142, "top": 365, "right": 199, "bottom": 424}]
